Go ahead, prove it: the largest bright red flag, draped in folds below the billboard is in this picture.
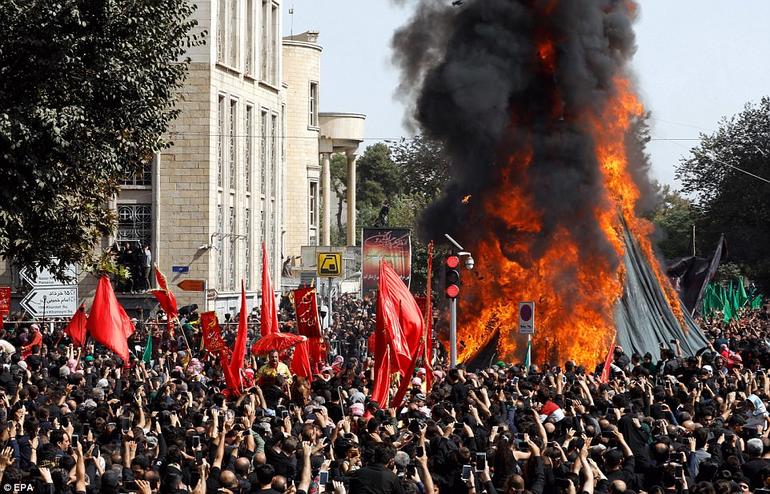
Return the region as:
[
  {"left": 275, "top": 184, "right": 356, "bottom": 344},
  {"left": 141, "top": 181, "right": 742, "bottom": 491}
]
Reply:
[{"left": 372, "top": 260, "right": 424, "bottom": 407}]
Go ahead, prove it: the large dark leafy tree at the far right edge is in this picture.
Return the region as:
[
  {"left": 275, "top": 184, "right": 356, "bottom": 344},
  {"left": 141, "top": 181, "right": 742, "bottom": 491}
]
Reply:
[{"left": 677, "top": 97, "right": 770, "bottom": 291}]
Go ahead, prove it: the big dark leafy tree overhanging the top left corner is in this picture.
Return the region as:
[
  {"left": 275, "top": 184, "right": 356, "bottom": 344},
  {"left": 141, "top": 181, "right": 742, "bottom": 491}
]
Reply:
[{"left": 0, "top": 0, "right": 202, "bottom": 275}]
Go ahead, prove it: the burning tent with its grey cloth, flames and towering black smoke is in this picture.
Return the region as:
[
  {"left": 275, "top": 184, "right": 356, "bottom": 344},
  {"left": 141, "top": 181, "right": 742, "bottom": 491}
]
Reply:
[{"left": 394, "top": 0, "right": 703, "bottom": 365}]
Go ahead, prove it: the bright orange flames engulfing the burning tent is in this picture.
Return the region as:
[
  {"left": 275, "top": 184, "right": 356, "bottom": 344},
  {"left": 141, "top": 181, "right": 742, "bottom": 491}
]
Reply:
[{"left": 452, "top": 13, "right": 682, "bottom": 366}]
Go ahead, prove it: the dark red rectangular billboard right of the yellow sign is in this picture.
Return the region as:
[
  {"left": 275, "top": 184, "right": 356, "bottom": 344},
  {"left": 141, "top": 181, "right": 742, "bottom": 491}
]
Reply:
[{"left": 361, "top": 228, "right": 412, "bottom": 296}]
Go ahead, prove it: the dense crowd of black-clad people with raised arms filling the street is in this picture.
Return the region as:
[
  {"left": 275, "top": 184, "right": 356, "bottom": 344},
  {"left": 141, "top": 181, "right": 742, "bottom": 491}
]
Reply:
[{"left": 0, "top": 290, "right": 770, "bottom": 494}]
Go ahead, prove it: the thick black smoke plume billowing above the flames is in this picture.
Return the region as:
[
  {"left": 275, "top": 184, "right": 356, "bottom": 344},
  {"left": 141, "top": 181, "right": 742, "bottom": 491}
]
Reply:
[{"left": 393, "top": 0, "right": 650, "bottom": 265}]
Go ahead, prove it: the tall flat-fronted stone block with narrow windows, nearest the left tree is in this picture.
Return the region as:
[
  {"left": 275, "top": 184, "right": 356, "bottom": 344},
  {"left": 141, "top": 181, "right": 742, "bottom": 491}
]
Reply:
[{"left": 0, "top": 0, "right": 287, "bottom": 314}]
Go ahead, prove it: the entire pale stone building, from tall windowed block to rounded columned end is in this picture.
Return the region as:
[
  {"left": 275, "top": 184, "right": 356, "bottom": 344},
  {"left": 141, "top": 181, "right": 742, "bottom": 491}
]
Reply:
[{"left": 0, "top": 5, "right": 364, "bottom": 316}]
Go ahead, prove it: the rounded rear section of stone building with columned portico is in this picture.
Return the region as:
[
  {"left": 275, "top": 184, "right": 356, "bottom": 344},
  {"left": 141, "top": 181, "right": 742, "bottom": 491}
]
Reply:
[{"left": 283, "top": 31, "right": 365, "bottom": 287}]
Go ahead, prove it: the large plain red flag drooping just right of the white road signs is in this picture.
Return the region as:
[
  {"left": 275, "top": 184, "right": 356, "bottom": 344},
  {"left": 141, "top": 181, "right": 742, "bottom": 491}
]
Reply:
[{"left": 86, "top": 276, "right": 134, "bottom": 363}]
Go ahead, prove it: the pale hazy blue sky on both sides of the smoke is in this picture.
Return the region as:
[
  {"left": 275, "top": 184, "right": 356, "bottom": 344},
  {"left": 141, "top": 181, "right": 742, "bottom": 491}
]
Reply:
[{"left": 283, "top": 0, "right": 770, "bottom": 187}]
